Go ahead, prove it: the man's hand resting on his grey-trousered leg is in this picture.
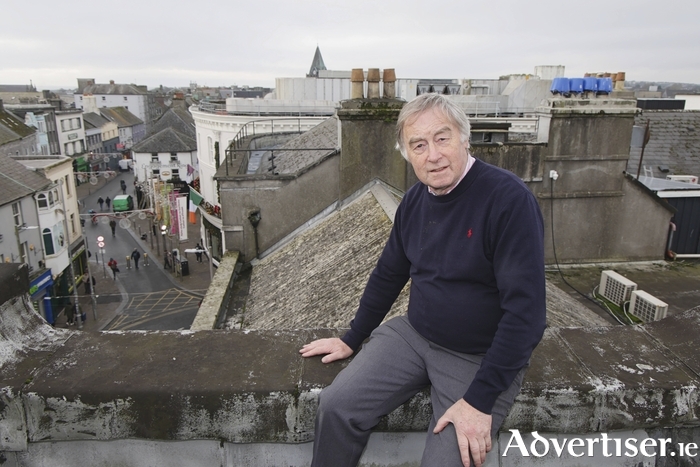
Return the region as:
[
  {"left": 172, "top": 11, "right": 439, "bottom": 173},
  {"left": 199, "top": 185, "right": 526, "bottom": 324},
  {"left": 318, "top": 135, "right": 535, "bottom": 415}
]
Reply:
[{"left": 433, "top": 399, "right": 491, "bottom": 467}]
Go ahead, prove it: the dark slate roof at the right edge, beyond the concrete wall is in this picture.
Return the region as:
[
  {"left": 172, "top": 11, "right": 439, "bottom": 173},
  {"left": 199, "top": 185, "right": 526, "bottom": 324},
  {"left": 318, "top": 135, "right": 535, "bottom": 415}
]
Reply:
[{"left": 627, "top": 110, "right": 700, "bottom": 178}]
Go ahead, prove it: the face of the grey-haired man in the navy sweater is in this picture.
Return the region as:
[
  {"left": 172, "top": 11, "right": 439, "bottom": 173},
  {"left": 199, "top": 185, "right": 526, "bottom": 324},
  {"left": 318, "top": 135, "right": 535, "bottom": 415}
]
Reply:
[{"left": 403, "top": 109, "right": 469, "bottom": 195}]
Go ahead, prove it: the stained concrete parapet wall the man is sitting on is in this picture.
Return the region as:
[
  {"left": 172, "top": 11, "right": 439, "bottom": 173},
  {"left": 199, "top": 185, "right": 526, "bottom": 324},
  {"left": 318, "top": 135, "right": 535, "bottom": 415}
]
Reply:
[{"left": 0, "top": 258, "right": 700, "bottom": 466}]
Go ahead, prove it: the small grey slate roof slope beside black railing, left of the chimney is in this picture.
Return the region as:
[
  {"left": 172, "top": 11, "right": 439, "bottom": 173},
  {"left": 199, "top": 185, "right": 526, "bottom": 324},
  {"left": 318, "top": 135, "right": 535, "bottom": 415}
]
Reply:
[{"left": 258, "top": 116, "right": 340, "bottom": 174}]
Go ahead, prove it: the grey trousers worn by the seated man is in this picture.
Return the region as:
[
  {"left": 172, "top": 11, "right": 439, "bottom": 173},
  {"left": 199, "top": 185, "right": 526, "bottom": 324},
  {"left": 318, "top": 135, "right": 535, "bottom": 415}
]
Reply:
[{"left": 311, "top": 316, "right": 524, "bottom": 467}]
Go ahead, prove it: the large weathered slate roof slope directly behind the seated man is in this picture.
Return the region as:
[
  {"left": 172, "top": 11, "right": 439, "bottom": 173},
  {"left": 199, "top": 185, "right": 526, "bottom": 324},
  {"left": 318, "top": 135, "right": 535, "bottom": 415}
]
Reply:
[{"left": 239, "top": 184, "right": 609, "bottom": 330}]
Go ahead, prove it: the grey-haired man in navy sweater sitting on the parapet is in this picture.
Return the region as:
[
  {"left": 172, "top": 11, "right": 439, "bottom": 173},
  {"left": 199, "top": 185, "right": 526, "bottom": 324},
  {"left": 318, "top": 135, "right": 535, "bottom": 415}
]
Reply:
[{"left": 300, "top": 94, "right": 545, "bottom": 467}]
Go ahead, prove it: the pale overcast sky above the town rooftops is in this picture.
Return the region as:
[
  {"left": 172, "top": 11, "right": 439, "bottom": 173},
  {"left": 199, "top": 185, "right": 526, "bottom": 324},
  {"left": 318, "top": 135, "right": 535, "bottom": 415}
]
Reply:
[{"left": 0, "top": 0, "right": 700, "bottom": 90}]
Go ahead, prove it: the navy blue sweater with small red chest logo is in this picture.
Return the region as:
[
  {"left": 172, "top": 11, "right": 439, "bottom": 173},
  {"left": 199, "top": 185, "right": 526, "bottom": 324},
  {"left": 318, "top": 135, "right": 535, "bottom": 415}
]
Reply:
[{"left": 342, "top": 159, "right": 545, "bottom": 414}]
